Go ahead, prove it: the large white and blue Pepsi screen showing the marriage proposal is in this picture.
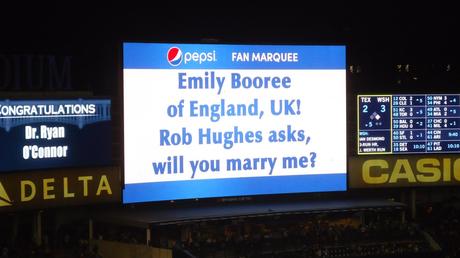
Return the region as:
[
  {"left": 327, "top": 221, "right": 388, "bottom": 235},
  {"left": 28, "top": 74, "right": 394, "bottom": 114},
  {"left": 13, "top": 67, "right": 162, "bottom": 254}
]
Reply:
[{"left": 123, "top": 43, "right": 347, "bottom": 203}]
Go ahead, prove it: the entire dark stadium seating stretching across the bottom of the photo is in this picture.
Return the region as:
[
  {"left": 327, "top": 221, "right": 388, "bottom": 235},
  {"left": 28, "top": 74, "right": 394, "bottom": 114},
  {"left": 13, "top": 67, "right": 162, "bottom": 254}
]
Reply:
[{"left": 0, "top": 200, "right": 460, "bottom": 258}]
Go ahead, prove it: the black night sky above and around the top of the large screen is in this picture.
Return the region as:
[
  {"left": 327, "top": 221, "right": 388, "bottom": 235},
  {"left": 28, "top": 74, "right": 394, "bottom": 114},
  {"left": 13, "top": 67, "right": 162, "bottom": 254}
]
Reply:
[{"left": 0, "top": 1, "right": 460, "bottom": 92}]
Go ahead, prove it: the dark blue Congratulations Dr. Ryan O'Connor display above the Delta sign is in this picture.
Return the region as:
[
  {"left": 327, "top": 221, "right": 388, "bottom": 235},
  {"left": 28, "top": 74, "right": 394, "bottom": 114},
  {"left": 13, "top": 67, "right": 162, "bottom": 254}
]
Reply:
[{"left": 0, "top": 99, "right": 112, "bottom": 172}]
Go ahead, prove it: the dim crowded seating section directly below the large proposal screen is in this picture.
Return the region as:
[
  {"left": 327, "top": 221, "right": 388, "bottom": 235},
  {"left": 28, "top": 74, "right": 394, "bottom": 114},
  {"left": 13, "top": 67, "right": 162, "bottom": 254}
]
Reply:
[{"left": 160, "top": 214, "right": 440, "bottom": 258}]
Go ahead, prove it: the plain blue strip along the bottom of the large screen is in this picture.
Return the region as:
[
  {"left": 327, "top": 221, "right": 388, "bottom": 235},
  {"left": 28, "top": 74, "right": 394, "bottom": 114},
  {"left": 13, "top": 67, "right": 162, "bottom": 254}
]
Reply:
[{"left": 123, "top": 173, "right": 346, "bottom": 203}]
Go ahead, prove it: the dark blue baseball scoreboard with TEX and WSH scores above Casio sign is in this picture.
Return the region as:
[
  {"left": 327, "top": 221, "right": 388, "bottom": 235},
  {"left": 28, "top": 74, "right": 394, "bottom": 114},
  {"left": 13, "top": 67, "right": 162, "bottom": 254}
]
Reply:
[{"left": 357, "top": 94, "right": 460, "bottom": 155}]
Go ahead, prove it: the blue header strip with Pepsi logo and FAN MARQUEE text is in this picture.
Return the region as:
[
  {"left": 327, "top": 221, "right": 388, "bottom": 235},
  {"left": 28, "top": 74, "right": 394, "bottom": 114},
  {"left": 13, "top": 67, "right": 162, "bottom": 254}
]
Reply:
[{"left": 123, "top": 43, "right": 345, "bottom": 69}]
